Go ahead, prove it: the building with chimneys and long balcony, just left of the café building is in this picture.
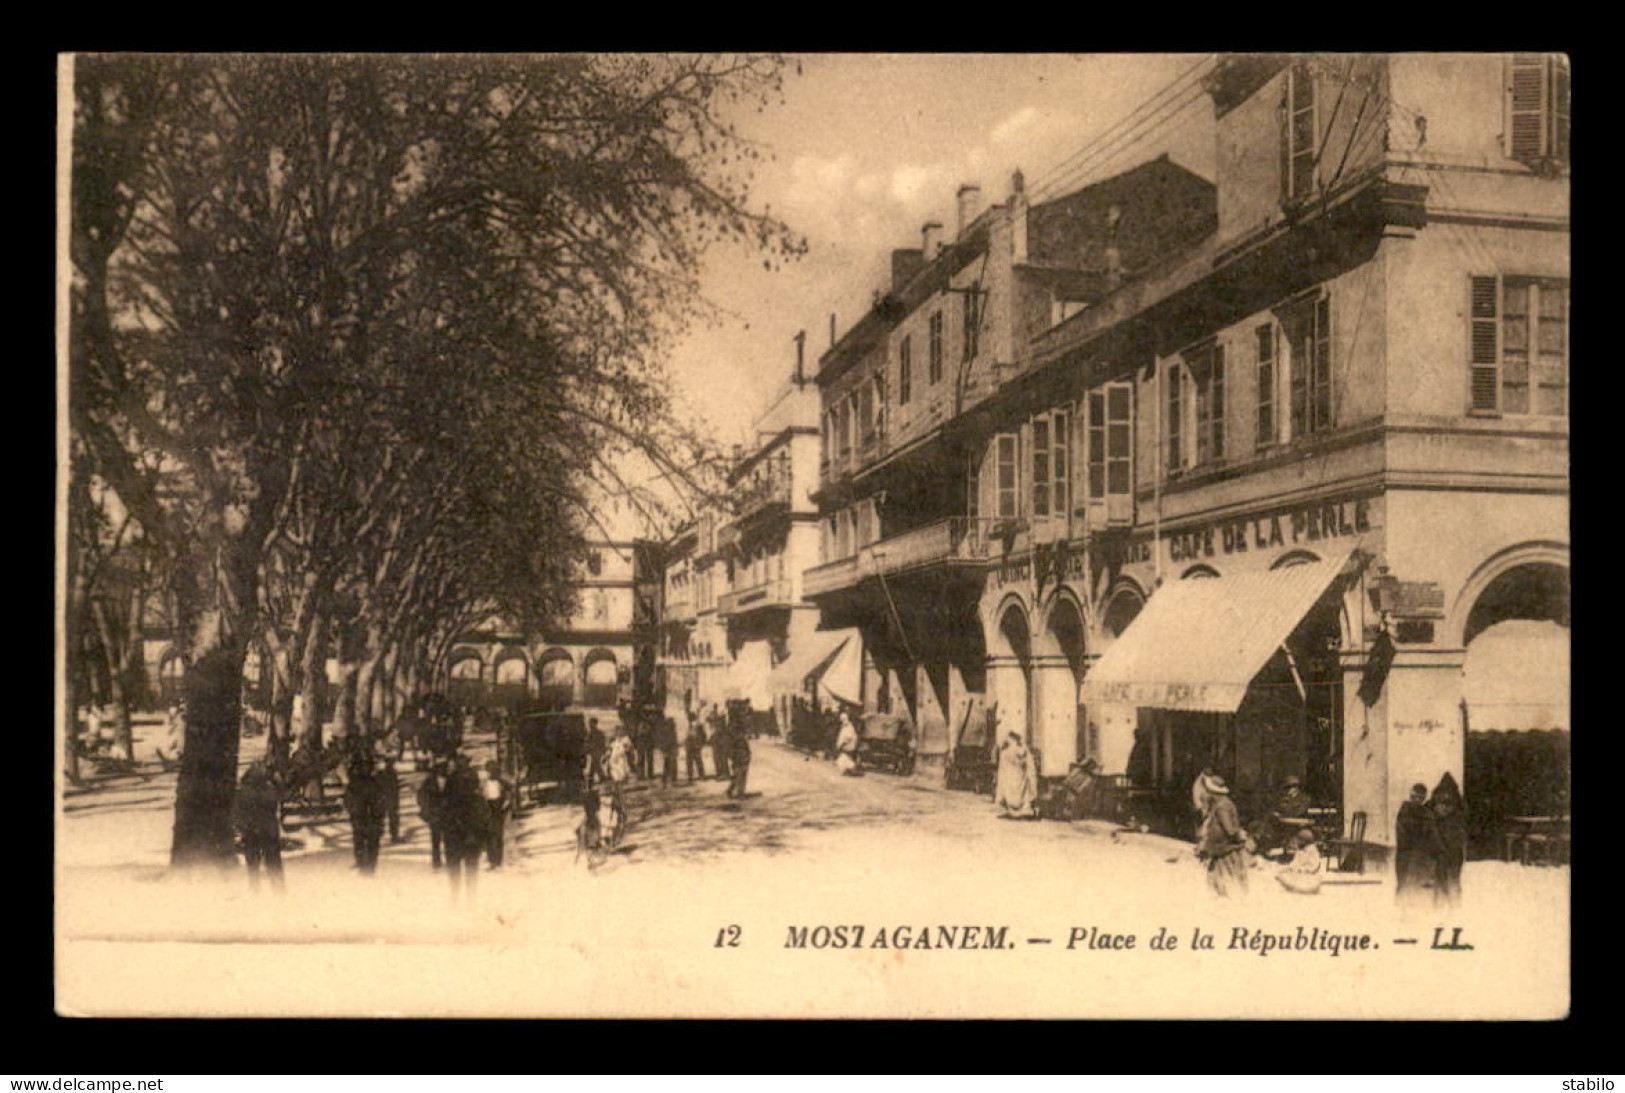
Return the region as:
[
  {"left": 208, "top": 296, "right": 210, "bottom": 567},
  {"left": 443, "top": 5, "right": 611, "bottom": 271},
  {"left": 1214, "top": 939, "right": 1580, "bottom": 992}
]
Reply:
[{"left": 806, "top": 158, "right": 1214, "bottom": 773}]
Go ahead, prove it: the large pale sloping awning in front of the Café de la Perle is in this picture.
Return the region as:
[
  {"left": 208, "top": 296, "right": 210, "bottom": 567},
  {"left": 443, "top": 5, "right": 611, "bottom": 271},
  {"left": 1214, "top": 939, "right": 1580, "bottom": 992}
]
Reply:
[{"left": 1082, "top": 551, "right": 1352, "bottom": 713}]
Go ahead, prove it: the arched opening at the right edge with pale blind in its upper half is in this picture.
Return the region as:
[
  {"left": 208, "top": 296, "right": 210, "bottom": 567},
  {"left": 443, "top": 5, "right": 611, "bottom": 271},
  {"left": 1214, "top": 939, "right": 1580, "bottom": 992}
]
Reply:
[{"left": 1463, "top": 562, "right": 1570, "bottom": 858}]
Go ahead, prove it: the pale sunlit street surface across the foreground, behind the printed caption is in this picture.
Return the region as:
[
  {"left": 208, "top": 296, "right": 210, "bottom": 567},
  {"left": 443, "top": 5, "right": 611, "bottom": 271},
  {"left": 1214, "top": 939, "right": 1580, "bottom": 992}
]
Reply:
[{"left": 59, "top": 724, "right": 1568, "bottom": 1017}]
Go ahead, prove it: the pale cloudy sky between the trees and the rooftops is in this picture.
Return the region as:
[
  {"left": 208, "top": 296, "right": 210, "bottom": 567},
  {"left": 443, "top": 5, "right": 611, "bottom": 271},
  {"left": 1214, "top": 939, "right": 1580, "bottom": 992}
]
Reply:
[{"left": 668, "top": 54, "right": 1214, "bottom": 445}]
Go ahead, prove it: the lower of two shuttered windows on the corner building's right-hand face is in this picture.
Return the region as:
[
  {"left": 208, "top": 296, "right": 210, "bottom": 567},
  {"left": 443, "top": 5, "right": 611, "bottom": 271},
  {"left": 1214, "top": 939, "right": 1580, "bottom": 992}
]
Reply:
[{"left": 1469, "top": 276, "right": 1568, "bottom": 417}]
